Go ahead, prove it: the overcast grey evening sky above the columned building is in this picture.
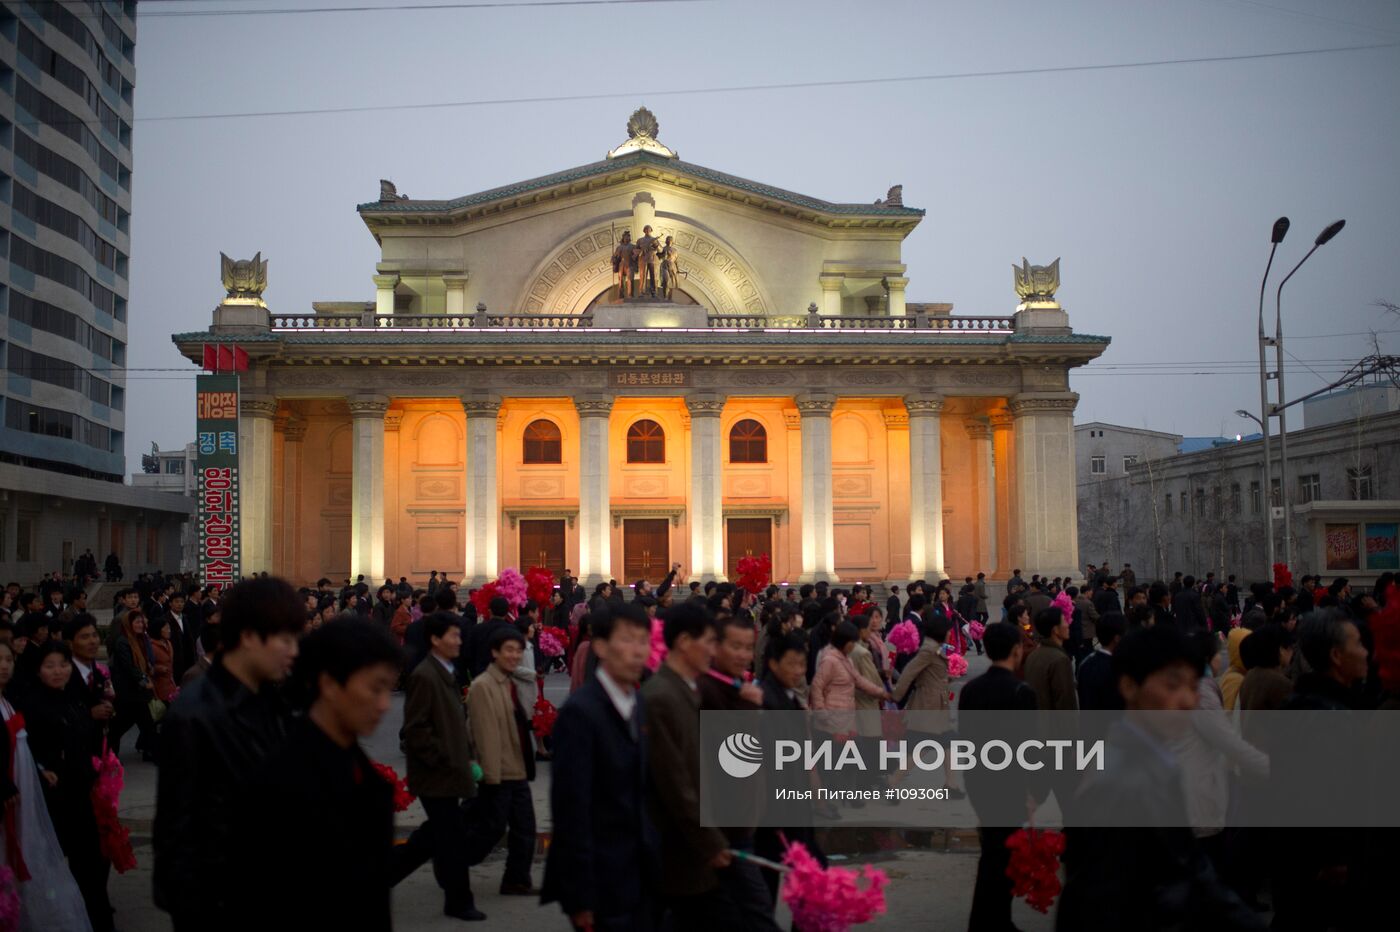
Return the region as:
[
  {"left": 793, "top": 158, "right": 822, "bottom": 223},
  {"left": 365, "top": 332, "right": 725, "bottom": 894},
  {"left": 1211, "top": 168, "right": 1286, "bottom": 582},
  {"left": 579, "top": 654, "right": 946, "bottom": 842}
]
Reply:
[{"left": 126, "top": 0, "right": 1400, "bottom": 472}]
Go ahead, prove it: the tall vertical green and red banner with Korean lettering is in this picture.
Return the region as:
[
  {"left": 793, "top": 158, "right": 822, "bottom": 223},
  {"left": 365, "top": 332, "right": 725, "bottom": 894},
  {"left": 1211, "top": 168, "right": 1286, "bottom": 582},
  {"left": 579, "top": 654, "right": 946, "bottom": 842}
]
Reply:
[{"left": 195, "top": 375, "right": 239, "bottom": 588}]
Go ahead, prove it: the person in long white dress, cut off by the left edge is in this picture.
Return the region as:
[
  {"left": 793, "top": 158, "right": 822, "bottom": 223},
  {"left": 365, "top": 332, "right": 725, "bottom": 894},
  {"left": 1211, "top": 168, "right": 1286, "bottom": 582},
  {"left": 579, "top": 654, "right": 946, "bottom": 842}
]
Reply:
[{"left": 0, "top": 641, "right": 92, "bottom": 932}]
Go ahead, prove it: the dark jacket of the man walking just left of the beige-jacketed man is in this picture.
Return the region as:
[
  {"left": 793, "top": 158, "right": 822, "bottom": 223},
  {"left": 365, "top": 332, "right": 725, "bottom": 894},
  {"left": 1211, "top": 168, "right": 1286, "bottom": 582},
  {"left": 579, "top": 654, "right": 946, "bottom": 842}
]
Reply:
[{"left": 399, "top": 654, "right": 476, "bottom": 798}]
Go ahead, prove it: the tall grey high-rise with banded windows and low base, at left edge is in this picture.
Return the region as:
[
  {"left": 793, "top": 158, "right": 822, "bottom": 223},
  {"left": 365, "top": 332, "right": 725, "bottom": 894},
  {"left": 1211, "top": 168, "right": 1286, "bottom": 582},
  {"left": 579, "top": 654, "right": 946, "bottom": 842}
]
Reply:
[{"left": 0, "top": 0, "right": 188, "bottom": 582}]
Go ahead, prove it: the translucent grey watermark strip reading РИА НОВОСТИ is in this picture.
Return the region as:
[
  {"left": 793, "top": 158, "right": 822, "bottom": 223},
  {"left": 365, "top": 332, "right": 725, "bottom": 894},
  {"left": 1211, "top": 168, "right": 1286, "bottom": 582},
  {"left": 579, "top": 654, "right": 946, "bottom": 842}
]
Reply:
[{"left": 699, "top": 711, "right": 1400, "bottom": 828}]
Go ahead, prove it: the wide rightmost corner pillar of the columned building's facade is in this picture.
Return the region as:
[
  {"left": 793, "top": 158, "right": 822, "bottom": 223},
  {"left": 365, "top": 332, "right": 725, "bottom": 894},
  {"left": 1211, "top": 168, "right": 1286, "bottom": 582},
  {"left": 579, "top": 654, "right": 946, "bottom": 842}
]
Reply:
[{"left": 1011, "top": 392, "right": 1079, "bottom": 575}]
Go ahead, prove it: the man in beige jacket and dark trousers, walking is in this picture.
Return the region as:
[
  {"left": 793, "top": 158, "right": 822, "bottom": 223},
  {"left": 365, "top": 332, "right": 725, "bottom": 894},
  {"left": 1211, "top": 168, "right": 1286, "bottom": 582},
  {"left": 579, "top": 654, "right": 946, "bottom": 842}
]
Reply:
[{"left": 466, "top": 628, "right": 539, "bottom": 896}]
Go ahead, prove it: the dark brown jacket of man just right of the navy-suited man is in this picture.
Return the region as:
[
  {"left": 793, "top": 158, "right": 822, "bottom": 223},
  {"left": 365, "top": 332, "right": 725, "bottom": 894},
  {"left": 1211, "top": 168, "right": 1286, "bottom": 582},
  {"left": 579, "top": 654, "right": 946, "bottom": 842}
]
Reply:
[{"left": 641, "top": 665, "right": 728, "bottom": 896}]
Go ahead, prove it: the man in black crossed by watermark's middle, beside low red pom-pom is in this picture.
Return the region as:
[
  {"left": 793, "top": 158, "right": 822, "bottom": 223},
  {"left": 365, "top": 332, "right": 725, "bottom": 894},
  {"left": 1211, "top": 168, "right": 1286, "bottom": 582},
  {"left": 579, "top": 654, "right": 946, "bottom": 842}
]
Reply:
[{"left": 958, "top": 623, "right": 1036, "bottom": 932}]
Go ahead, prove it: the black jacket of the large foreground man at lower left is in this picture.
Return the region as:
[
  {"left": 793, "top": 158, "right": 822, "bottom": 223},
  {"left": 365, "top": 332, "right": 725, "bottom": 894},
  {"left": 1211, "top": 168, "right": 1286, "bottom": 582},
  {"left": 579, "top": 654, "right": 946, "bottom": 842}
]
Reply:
[{"left": 244, "top": 719, "right": 393, "bottom": 932}]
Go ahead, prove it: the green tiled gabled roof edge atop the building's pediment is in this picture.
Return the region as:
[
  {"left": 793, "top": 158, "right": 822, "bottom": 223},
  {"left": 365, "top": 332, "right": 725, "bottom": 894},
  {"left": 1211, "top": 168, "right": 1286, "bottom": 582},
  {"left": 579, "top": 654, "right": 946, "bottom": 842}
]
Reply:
[{"left": 358, "top": 151, "right": 924, "bottom": 217}]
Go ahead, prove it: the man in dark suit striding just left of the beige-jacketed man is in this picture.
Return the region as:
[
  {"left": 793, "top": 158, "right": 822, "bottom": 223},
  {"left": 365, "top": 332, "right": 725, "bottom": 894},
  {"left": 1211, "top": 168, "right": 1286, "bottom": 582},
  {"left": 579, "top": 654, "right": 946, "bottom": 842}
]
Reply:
[{"left": 391, "top": 612, "right": 486, "bottom": 921}]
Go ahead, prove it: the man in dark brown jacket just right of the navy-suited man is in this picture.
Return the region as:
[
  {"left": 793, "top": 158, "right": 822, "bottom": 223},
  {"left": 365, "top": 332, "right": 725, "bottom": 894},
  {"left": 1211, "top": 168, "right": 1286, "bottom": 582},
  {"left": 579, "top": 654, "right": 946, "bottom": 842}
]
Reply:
[{"left": 641, "top": 603, "right": 743, "bottom": 932}]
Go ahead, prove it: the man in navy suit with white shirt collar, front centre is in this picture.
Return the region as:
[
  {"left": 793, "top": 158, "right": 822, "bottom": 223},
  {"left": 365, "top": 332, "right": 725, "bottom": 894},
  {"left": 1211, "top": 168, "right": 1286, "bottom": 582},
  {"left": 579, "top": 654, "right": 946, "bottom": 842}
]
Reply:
[{"left": 540, "top": 601, "right": 659, "bottom": 932}]
